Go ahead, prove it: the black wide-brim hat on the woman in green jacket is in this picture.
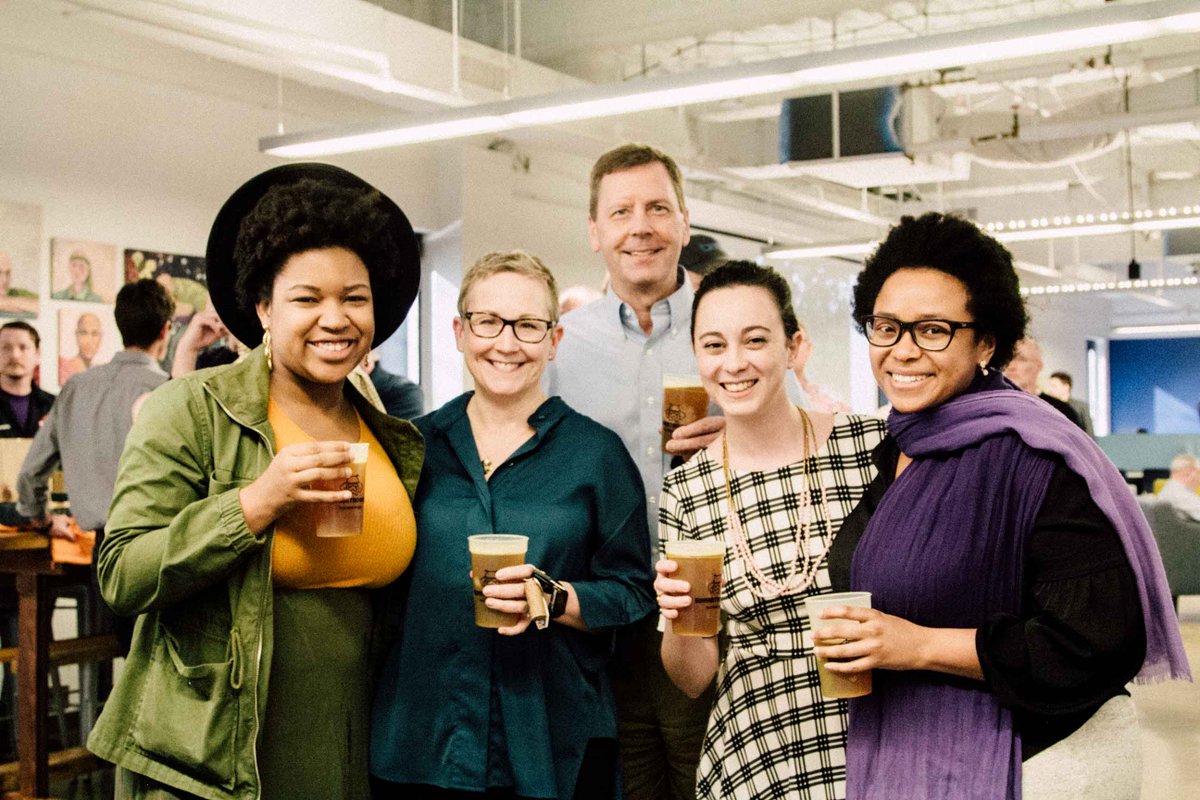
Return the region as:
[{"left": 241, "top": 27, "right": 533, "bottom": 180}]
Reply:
[{"left": 206, "top": 163, "right": 421, "bottom": 347}]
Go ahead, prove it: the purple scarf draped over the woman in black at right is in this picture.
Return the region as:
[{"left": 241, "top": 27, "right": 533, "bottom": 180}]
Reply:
[{"left": 846, "top": 374, "right": 1190, "bottom": 800}]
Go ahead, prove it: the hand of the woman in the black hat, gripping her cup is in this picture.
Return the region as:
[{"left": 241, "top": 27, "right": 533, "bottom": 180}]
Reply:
[{"left": 238, "top": 441, "right": 352, "bottom": 534}]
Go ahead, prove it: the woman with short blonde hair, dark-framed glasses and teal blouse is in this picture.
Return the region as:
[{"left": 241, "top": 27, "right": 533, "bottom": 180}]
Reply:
[{"left": 371, "top": 251, "right": 654, "bottom": 800}]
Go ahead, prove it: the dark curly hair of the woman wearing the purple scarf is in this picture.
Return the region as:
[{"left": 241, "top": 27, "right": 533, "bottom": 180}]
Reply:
[{"left": 853, "top": 211, "right": 1028, "bottom": 368}]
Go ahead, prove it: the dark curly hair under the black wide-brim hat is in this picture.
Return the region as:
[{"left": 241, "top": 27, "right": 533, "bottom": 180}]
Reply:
[{"left": 233, "top": 178, "right": 403, "bottom": 318}]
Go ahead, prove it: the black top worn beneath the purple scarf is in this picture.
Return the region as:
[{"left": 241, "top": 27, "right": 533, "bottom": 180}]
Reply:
[{"left": 829, "top": 437, "right": 1146, "bottom": 759}]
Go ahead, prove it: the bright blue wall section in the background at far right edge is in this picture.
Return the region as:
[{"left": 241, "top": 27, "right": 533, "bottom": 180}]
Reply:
[{"left": 1109, "top": 337, "right": 1200, "bottom": 433}]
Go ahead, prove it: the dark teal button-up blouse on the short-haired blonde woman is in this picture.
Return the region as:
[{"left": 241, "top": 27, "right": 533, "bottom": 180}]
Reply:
[{"left": 371, "top": 392, "right": 655, "bottom": 799}]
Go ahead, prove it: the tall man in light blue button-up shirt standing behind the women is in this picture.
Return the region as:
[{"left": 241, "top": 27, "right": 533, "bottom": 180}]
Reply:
[{"left": 547, "top": 144, "right": 713, "bottom": 800}]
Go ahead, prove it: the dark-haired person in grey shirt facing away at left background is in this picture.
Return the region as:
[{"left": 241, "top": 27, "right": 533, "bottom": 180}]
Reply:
[{"left": 17, "top": 279, "right": 175, "bottom": 652}]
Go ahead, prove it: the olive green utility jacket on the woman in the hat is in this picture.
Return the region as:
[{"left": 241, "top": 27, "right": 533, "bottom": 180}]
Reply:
[{"left": 88, "top": 348, "right": 425, "bottom": 800}]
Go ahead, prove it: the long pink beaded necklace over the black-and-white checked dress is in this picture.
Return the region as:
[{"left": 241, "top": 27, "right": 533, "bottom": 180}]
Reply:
[{"left": 721, "top": 408, "right": 833, "bottom": 600}]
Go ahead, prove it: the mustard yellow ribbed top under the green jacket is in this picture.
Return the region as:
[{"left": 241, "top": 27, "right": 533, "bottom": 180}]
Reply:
[{"left": 266, "top": 399, "right": 416, "bottom": 589}]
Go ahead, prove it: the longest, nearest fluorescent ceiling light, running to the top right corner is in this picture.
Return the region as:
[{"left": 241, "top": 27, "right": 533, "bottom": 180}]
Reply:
[{"left": 259, "top": 0, "right": 1200, "bottom": 156}]
